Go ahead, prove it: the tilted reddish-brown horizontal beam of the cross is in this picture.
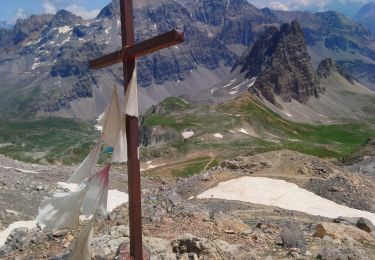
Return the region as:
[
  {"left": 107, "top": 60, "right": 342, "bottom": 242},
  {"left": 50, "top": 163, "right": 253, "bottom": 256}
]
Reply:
[{"left": 89, "top": 30, "right": 185, "bottom": 69}]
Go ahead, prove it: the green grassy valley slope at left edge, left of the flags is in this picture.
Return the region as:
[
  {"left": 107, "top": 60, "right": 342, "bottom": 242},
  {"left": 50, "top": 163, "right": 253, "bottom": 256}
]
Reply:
[{"left": 0, "top": 118, "right": 96, "bottom": 164}]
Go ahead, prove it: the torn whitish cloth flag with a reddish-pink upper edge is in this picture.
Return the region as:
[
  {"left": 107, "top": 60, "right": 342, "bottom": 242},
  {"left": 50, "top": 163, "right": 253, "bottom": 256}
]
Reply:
[{"left": 81, "top": 165, "right": 111, "bottom": 216}]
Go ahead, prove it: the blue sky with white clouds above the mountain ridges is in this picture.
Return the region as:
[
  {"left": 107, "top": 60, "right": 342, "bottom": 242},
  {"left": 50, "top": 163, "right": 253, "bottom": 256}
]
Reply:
[{"left": 0, "top": 0, "right": 375, "bottom": 24}]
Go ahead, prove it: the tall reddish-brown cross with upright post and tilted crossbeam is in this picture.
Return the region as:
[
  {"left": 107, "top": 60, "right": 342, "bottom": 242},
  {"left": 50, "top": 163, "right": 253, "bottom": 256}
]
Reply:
[{"left": 90, "top": 0, "right": 184, "bottom": 260}]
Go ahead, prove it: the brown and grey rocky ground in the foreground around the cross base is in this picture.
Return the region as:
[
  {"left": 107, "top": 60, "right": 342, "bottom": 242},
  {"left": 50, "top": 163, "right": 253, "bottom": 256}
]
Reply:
[{"left": 0, "top": 150, "right": 375, "bottom": 259}]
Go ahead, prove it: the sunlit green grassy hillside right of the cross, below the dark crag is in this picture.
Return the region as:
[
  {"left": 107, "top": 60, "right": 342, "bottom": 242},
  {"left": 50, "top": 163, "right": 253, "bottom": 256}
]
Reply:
[{"left": 145, "top": 94, "right": 375, "bottom": 159}]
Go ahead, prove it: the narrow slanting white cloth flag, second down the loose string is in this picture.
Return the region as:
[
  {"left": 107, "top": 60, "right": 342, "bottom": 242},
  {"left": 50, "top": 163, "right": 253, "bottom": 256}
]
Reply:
[{"left": 67, "top": 139, "right": 102, "bottom": 184}]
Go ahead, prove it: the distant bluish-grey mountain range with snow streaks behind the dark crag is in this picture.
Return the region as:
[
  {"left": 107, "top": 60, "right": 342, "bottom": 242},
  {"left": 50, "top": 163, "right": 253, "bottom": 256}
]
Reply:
[{"left": 0, "top": 0, "right": 375, "bottom": 120}]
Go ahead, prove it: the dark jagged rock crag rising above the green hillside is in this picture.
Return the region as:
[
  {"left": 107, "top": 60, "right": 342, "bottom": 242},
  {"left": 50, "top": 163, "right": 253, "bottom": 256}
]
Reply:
[{"left": 235, "top": 21, "right": 321, "bottom": 104}]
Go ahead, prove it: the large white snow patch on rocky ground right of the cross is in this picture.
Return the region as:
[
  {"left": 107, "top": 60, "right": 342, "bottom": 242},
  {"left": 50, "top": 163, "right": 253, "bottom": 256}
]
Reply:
[{"left": 197, "top": 177, "right": 375, "bottom": 224}]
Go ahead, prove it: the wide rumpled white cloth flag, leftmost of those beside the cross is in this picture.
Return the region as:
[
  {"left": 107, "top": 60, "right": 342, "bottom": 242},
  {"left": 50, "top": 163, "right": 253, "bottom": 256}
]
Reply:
[{"left": 37, "top": 185, "right": 86, "bottom": 231}]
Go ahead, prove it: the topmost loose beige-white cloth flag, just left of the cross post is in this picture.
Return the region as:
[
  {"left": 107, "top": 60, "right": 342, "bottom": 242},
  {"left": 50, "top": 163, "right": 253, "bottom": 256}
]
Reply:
[{"left": 99, "top": 87, "right": 124, "bottom": 147}]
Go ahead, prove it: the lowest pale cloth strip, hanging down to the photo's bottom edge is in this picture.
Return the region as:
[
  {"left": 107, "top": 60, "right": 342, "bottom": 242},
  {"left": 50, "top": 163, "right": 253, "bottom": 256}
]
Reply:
[{"left": 69, "top": 215, "right": 96, "bottom": 260}]
